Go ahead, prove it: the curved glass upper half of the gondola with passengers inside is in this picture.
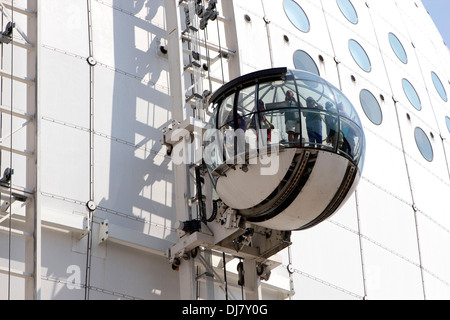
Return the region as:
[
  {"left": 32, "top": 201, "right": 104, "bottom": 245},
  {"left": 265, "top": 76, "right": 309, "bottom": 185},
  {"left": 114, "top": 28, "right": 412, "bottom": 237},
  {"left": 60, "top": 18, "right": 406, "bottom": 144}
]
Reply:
[{"left": 205, "top": 68, "right": 365, "bottom": 175}]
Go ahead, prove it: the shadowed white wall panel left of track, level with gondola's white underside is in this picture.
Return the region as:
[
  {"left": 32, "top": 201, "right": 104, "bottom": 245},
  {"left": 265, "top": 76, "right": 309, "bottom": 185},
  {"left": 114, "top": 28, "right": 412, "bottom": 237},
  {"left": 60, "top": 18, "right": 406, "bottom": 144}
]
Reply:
[{"left": 94, "top": 137, "right": 176, "bottom": 239}]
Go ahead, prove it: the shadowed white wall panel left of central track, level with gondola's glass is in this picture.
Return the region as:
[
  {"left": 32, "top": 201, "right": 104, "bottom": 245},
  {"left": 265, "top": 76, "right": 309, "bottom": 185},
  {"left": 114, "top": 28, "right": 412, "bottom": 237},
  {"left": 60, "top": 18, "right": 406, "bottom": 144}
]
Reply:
[{"left": 94, "top": 66, "right": 172, "bottom": 146}]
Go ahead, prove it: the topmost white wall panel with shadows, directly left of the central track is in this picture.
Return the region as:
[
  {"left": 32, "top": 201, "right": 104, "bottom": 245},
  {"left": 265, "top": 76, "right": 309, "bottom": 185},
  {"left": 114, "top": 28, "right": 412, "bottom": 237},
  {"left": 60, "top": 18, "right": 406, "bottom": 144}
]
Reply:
[{"left": 92, "top": 1, "right": 166, "bottom": 84}]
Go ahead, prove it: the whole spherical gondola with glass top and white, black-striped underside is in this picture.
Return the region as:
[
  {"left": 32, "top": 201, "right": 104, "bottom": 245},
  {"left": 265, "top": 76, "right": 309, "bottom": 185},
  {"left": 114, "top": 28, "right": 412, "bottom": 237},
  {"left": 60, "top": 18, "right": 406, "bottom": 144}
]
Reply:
[{"left": 204, "top": 68, "right": 365, "bottom": 231}]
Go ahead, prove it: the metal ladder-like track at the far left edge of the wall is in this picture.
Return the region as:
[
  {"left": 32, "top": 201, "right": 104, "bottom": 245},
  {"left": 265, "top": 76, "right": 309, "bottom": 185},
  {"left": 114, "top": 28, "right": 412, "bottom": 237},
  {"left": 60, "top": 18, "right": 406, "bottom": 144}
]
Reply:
[{"left": 0, "top": 0, "right": 41, "bottom": 300}]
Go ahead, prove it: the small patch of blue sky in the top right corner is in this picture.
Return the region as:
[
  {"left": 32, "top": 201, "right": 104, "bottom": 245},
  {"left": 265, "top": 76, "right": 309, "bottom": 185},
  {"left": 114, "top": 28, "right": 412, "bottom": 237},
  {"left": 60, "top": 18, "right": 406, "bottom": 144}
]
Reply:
[{"left": 422, "top": 0, "right": 450, "bottom": 49}]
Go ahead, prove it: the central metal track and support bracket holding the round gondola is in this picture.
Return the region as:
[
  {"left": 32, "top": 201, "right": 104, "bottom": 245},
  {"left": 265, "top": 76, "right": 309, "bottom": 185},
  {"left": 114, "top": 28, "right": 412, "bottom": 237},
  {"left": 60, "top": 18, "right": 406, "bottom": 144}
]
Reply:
[{"left": 160, "top": 0, "right": 290, "bottom": 300}]
